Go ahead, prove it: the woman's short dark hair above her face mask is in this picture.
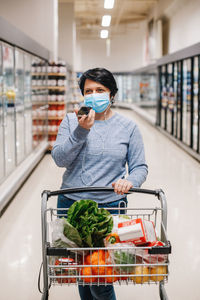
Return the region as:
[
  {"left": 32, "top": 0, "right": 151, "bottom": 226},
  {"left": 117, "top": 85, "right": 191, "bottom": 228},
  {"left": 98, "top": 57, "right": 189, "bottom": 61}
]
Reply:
[{"left": 79, "top": 68, "right": 118, "bottom": 97}]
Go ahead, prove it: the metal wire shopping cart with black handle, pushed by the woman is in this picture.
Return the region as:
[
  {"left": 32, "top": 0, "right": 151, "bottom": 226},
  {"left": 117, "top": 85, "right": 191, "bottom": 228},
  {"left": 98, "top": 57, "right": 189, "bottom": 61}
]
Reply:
[{"left": 38, "top": 187, "right": 171, "bottom": 300}]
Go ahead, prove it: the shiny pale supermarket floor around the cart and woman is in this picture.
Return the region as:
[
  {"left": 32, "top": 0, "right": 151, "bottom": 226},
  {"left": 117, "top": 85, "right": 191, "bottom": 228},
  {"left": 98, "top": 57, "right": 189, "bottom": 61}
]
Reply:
[{"left": 0, "top": 110, "right": 200, "bottom": 300}]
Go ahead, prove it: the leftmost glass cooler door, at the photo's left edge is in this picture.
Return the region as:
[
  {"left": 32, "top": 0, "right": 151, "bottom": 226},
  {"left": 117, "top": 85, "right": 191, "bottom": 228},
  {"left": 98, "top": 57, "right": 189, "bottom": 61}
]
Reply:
[{"left": 2, "top": 44, "right": 15, "bottom": 175}]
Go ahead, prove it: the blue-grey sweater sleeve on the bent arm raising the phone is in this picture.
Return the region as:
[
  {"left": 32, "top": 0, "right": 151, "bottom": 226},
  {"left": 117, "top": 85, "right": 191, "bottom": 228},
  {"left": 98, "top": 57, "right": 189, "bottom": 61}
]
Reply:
[{"left": 51, "top": 116, "right": 89, "bottom": 168}]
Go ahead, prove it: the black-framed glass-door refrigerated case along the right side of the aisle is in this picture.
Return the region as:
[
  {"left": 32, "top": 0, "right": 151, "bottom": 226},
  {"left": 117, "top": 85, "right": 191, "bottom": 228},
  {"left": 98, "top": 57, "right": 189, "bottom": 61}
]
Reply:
[{"left": 157, "top": 44, "right": 200, "bottom": 160}]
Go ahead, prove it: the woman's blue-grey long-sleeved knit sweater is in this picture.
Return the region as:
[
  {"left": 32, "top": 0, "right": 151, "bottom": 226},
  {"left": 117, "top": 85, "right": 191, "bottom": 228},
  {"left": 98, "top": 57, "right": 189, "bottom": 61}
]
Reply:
[{"left": 52, "top": 113, "right": 148, "bottom": 203}]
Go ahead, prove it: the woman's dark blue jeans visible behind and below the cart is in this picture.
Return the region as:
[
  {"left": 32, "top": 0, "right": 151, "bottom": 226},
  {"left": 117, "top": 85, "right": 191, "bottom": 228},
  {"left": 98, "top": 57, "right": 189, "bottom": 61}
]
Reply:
[{"left": 57, "top": 195, "right": 127, "bottom": 300}]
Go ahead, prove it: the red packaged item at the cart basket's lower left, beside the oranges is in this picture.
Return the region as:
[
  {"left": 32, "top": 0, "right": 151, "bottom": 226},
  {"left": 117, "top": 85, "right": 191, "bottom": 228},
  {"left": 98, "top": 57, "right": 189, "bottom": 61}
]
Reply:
[{"left": 54, "top": 257, "right": 78, "bottom": 283}]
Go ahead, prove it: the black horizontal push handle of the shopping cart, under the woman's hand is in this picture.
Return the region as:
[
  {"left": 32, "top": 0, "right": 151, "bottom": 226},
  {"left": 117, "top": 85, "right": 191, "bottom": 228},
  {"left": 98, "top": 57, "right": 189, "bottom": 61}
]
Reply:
[{"left": 42, "top": 186, "right": 163, "bottom": 198}]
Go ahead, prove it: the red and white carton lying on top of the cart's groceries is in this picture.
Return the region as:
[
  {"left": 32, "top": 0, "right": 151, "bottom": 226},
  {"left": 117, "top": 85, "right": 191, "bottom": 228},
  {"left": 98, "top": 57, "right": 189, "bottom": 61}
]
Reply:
[{"left": 118, "top": 218, "right": 156, "bottom": 245}]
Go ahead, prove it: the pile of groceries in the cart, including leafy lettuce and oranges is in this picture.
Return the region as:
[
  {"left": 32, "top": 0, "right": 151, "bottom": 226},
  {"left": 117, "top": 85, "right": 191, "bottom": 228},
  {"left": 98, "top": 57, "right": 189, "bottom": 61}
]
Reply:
[{"left": 50, "top": 200, "right": 168, "bottom": 284}]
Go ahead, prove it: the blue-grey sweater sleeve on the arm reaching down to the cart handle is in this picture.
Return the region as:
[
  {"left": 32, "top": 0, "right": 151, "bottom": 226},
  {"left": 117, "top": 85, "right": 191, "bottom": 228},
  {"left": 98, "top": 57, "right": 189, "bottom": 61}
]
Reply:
[{"left": 126, "top": 125, "right": 148, "bottom": 187}]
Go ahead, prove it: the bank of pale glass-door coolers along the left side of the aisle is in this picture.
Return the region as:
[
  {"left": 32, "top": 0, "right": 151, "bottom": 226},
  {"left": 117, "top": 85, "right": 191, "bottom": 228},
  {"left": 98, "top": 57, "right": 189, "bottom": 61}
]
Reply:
[{"left": 0, "top": 42, "right": 48, "bottom": 181}]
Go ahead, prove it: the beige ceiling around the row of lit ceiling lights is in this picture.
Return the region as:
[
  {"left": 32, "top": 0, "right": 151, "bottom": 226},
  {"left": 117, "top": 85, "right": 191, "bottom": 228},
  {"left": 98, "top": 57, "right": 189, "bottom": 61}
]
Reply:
[{"left": 59, "top": 0, "right": 158, "bottom": 39}]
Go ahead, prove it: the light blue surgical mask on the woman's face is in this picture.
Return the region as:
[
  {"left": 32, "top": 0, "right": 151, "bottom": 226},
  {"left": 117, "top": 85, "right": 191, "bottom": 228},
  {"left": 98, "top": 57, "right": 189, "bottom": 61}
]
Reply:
[{"left": 84, "top": 93, "right": 110, "bottom": 113}]
